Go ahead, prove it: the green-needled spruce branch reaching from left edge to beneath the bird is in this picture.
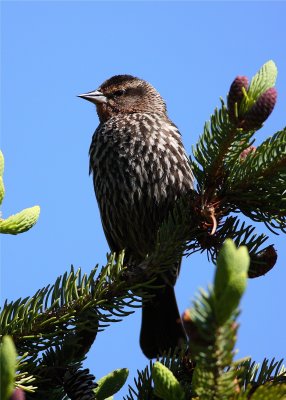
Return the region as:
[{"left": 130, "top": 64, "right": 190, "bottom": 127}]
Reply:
[{"left": 0, "top": 254, "right": 140, "bottom": 344}]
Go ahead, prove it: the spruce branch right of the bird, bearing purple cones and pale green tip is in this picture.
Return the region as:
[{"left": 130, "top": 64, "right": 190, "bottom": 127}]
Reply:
[{"left": 154, "top": 61, "right": 286, "bottom": 277}]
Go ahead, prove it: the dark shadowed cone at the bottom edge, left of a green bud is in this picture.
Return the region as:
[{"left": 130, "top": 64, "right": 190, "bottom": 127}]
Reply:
[{"left": 64, "top": 369, "right": 97, "bottom": 400}]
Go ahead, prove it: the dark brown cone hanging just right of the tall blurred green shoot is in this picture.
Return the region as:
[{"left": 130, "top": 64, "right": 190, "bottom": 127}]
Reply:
[{"left": 248, "top": 245, "right": 277, "bottom": 278}]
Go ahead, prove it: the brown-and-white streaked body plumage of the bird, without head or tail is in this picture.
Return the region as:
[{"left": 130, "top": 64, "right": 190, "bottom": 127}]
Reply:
[{"left": 90, "top": 113, "right": 191, "bottom": 260}]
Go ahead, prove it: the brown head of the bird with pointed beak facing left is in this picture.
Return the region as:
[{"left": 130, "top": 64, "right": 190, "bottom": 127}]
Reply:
[{"left": 79, "top": 75, "right": 166, "bottom": 122}]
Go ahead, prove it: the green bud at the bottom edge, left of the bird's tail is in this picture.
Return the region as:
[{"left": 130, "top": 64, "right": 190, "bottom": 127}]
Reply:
[{"left": 93, "top": 368, "right": 129, "bottom": 400}]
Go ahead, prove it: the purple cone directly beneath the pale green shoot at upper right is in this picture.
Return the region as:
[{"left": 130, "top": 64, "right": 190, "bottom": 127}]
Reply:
[{"left": 239, "top": 87, "right": 277, "bottom": 130}]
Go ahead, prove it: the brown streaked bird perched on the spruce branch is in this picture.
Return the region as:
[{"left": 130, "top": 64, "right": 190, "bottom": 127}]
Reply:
[{"left": 79, "top": 75, "right": 194, "bottom": 359}]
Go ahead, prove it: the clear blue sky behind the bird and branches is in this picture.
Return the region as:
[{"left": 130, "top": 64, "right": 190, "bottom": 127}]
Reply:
[{"left": 1, "top": 1, "right": 286, "bottom": 399}]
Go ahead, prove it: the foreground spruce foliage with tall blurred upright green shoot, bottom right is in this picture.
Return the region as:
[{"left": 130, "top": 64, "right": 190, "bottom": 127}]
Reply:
[{"left": 125, "top": 240, "right": 286, "bottom": 400}]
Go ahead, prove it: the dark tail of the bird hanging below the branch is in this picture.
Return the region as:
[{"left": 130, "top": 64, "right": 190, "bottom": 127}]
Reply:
[{"left": 140, "top": 286, "right": 186, "bottom": 358}]
